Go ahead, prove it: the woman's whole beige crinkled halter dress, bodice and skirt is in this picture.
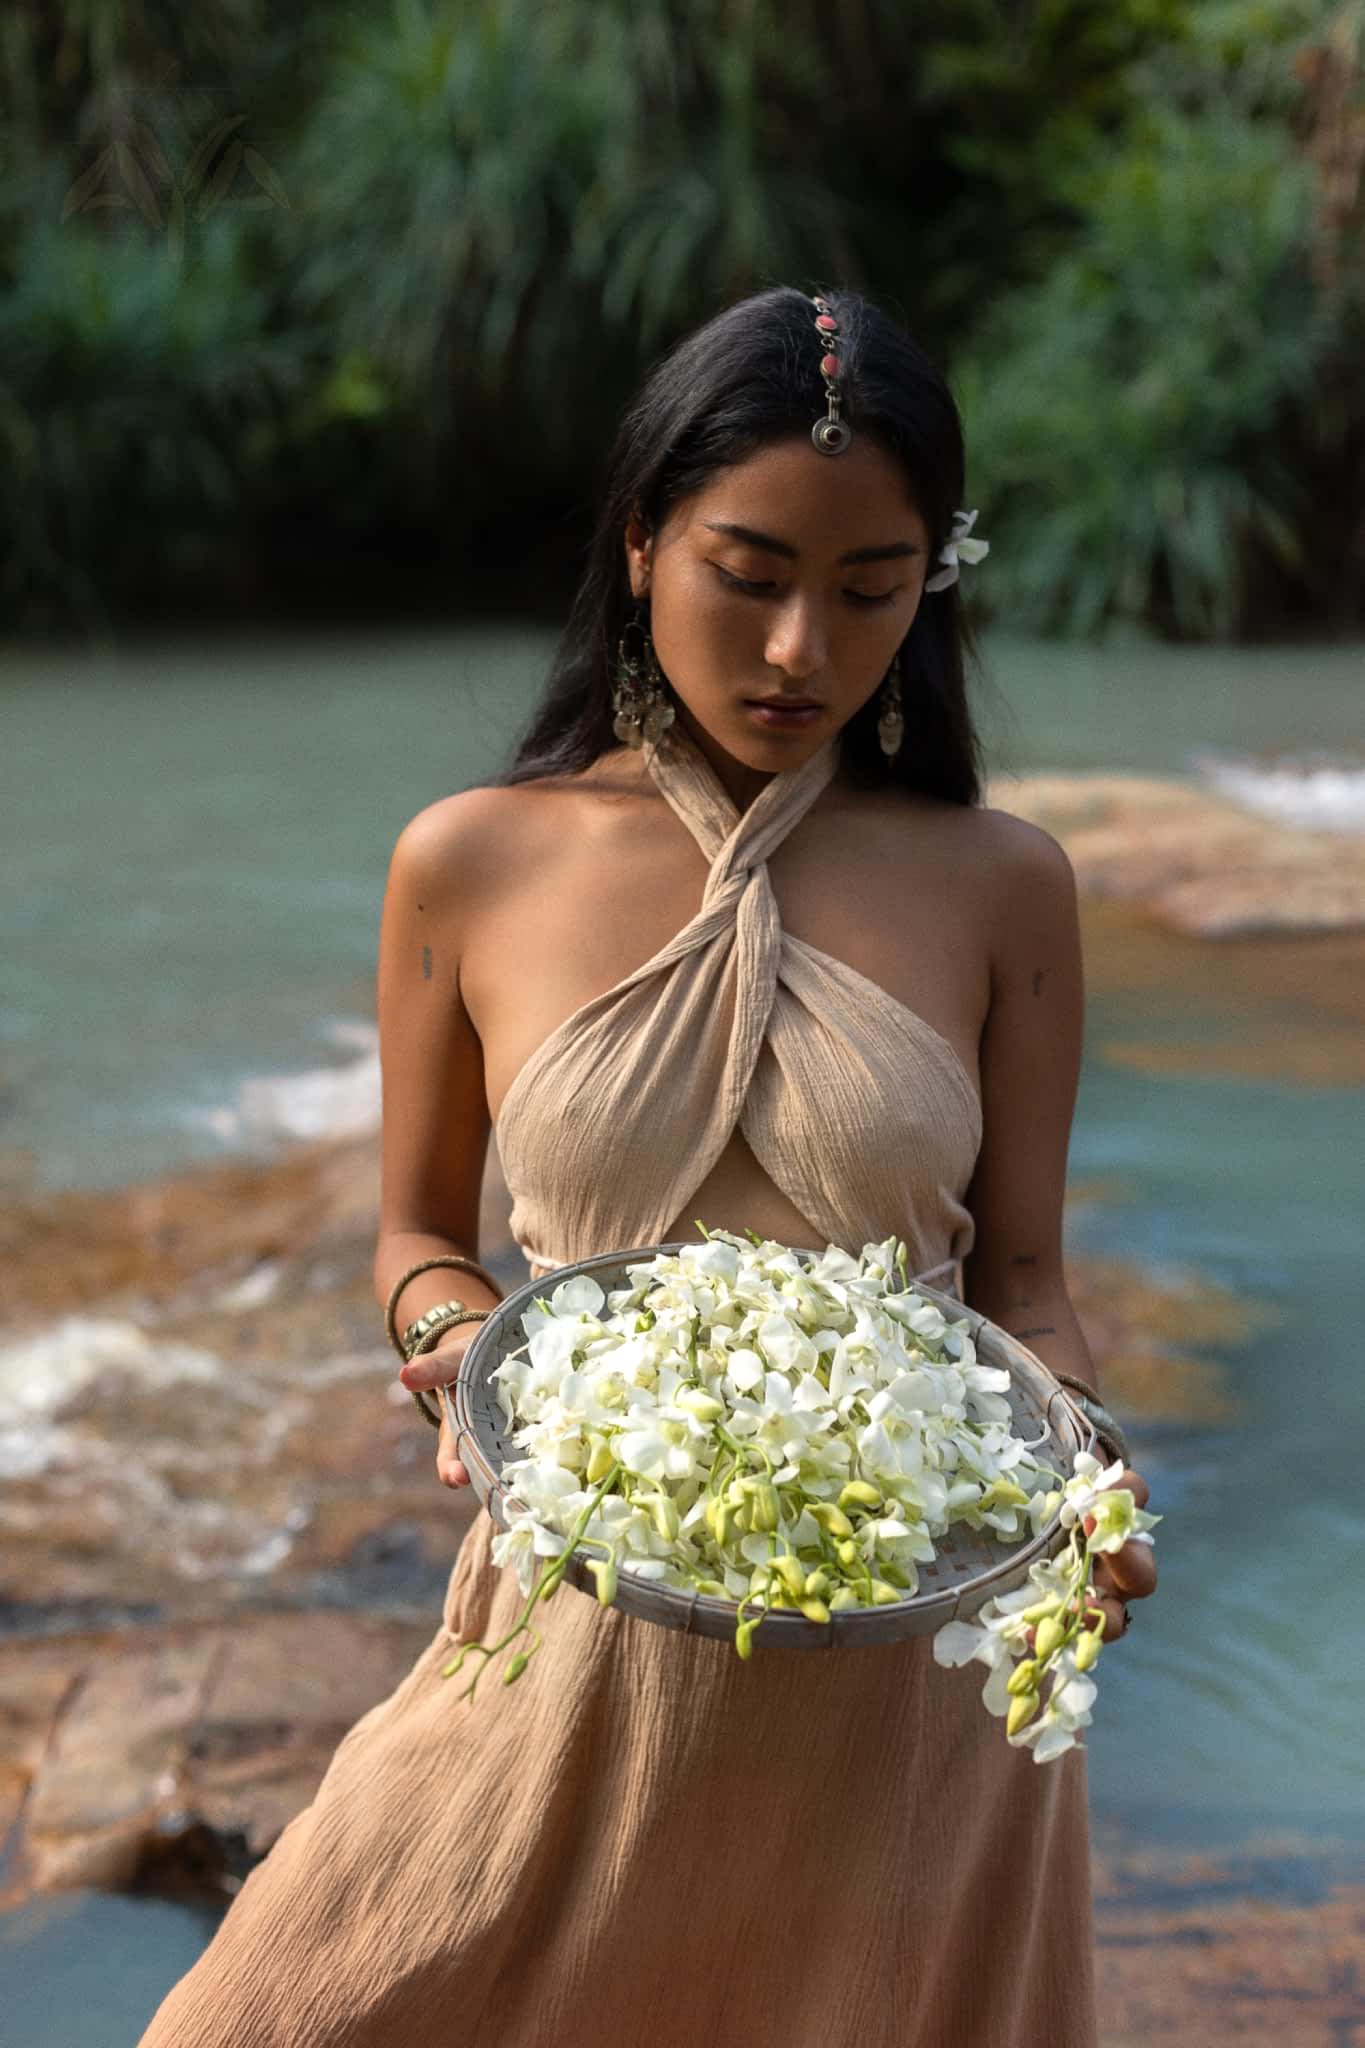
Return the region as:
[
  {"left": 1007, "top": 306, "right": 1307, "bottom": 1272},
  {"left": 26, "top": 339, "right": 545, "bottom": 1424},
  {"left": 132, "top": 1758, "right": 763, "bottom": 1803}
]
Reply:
[{"left": 143, "top": 729, "right": 1097, "bottom": 2048}]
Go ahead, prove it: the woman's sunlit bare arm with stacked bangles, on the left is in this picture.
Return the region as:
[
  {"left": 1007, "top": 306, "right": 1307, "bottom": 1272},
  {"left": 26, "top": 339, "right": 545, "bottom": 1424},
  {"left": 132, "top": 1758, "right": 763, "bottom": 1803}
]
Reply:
[{"left": 375, "top": 788, "right": 497, "bottom": 1487}]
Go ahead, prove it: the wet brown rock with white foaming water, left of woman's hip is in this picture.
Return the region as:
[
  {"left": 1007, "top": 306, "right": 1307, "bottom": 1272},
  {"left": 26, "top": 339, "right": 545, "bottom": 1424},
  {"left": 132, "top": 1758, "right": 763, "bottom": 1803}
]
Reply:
[{"left": 0, "top": 1141, "right": 507, "bottom": 1628}]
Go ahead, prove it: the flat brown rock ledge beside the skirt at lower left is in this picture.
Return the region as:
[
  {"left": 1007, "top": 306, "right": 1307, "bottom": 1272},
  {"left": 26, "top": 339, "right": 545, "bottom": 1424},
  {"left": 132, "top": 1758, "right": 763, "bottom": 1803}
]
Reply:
[{"left": 4, "top": 1612, "right": 432, "bottom": 1892}]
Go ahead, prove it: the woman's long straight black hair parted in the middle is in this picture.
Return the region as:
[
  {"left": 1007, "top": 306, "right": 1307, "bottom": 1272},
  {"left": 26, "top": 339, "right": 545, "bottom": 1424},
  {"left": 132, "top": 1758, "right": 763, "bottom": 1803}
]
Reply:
[{"left": 495, "top": 285, "right": 982, "bottom": 805}]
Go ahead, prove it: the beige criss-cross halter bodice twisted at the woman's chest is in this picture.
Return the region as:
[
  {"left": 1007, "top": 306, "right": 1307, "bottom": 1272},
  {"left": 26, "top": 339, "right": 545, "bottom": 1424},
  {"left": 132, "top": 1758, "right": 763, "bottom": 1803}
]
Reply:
[{"left": 497, "top": 727, "right": 980, "bottom": 1286}]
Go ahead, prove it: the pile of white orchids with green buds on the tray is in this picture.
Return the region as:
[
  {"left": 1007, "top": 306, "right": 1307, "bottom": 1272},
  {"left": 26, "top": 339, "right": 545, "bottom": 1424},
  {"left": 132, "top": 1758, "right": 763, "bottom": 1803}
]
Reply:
[{"left": 446, "top": 1223, "right": 1160, "bottom": 1763}]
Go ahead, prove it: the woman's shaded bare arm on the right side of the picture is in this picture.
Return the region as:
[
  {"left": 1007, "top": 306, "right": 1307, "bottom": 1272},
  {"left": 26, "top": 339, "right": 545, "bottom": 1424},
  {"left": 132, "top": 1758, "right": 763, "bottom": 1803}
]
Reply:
[{"left": 962, "top": 811, "right": 1156, "bottom": 1640}]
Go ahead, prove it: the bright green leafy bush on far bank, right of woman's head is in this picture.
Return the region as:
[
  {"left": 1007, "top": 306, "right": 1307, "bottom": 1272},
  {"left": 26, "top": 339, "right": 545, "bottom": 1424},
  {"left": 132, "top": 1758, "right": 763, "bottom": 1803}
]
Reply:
[{"left": 960, "top": 92, "right": 1322, "bottom": 637}]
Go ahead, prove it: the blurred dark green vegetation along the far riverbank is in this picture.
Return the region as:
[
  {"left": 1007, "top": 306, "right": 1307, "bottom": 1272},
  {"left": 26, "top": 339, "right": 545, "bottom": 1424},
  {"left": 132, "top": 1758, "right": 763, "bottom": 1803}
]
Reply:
[{"left": 0, "top": 0, "right": 1365, "bottom": 639}]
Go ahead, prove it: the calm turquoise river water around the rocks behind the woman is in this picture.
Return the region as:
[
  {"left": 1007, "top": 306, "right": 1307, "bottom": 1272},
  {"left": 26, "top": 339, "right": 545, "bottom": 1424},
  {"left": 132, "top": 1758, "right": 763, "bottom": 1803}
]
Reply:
[{"left": 0, "top": 631, "right": 1365, "bottom": 2048}]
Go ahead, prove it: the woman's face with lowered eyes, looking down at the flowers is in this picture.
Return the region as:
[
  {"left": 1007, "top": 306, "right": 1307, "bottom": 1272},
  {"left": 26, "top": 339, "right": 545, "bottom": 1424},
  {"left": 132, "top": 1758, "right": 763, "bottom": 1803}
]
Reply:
[{"left": 626, "top": 434, "right": 929, "bottom": 795}]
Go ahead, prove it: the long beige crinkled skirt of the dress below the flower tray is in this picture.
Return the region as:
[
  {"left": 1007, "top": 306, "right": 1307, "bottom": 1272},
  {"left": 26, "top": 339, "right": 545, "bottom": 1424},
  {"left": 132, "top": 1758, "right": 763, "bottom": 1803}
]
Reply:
[{"left": 141, "top": 1516, "right": 1097, "bottom": 2048}]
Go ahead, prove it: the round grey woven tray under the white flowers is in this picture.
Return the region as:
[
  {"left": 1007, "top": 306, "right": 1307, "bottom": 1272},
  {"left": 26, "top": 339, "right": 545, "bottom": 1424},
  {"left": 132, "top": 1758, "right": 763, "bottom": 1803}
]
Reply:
[{"left": 440, "top": 1241, "right": 1095, "bottom": 1649}]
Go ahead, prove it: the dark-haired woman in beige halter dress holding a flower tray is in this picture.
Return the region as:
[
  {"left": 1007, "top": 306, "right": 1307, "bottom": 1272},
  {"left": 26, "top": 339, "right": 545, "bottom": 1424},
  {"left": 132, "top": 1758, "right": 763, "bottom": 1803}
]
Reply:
[{"left": 145, "top": 289, "right": 1154, "bottom": 2048}]
